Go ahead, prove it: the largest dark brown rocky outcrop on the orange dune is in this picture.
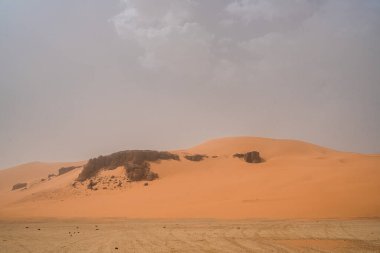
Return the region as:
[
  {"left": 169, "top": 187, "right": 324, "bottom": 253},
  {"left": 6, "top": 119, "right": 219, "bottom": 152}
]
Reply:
[{"left": 77, "top": 150, "right": 179, "bottom": 181}]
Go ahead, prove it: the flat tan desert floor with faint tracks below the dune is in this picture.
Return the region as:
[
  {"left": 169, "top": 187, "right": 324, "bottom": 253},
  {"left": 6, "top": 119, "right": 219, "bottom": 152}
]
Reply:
[{"left": 0, "top": 219, "right": 380, "bottom": 253}]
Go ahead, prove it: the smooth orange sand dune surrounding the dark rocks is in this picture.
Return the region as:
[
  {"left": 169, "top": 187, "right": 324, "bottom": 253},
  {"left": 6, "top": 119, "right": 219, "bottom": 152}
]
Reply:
[{"left": 0, "top": 137, "right": 380, "bottom": 219}]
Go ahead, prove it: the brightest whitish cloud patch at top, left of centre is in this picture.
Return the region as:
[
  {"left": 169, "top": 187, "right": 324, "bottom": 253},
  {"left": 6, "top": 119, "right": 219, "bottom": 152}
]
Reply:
[{"left": 112, "top": 1, "right": 220, "bottom": 82}]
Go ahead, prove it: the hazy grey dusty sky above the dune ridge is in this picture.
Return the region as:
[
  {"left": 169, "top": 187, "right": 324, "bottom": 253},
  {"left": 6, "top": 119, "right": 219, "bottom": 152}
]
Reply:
[{"left": 0, "top": 0, "right": 380, "bottom": 168}]
